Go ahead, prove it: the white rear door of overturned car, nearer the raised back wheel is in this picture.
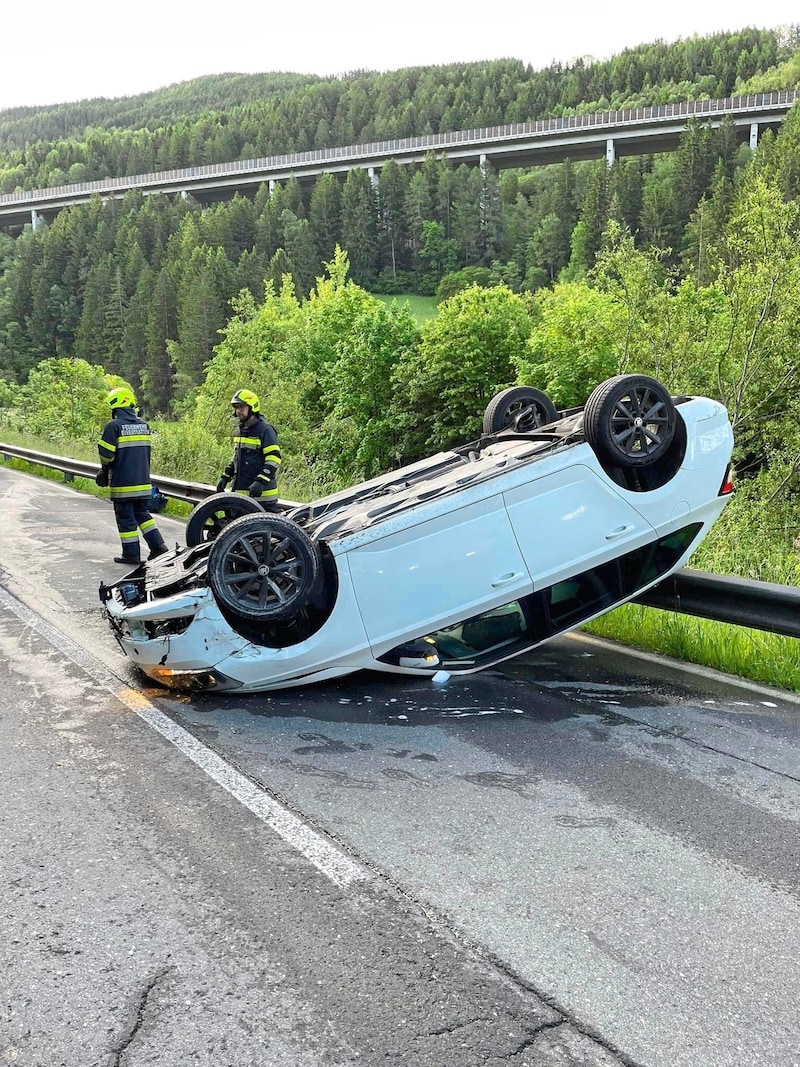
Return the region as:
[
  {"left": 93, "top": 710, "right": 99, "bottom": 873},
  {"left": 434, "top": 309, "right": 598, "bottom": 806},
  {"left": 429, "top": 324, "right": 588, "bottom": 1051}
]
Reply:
[{"left": 503, "top": 463, "right": 656, "bottom": 589}]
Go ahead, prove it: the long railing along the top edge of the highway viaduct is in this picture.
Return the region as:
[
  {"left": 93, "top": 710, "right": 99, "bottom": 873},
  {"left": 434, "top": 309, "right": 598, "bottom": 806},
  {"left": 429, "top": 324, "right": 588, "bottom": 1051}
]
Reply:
[{"left": 0, "top": 90, "right": 800, "bottom": 207}]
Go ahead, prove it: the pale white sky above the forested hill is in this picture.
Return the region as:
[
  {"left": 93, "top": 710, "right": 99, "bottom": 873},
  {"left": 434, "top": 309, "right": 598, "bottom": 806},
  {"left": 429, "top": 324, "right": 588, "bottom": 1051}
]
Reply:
[{"left": 0, "top": 0, "right": 800, "bottom": 111}]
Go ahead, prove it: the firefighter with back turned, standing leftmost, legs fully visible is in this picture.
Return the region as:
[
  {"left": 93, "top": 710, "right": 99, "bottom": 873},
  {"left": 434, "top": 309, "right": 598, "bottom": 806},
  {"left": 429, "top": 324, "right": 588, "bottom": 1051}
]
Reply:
[{"left": 95, "top": 385, "right": 169, "bottom": 566}]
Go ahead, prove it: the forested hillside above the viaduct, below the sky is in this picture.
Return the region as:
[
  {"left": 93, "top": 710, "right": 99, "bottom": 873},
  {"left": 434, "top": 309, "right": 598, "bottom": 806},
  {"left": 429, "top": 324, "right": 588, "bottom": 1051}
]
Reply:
[{"left": 0, "top": 28, "right": 798, "bottom": 192}]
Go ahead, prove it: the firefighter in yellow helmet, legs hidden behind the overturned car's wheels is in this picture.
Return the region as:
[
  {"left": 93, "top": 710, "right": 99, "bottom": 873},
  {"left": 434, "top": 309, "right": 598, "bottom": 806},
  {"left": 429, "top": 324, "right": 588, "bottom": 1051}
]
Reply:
[{"left": 217, "top": 389, "right": 281, "bottom": 511}]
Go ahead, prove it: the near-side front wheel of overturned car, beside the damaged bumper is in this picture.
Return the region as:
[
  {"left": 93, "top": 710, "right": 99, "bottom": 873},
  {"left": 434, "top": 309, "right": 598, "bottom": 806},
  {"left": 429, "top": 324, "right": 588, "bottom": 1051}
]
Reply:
[{"left": 208, "top": 513, "right": 321, "bottom": 620}]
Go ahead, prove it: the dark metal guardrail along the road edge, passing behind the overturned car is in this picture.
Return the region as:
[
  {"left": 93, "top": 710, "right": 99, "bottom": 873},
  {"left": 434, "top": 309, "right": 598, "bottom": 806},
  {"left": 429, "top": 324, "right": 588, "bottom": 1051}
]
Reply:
[{"left": 0, "top": 442, "right": 800, "bottom": 637}]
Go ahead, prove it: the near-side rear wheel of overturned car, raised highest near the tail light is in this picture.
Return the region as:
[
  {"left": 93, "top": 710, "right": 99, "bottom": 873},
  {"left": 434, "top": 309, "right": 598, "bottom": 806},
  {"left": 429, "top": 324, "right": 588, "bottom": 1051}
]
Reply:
[{"left": 583, "top": 375, "right": 677, "bottom": 467}]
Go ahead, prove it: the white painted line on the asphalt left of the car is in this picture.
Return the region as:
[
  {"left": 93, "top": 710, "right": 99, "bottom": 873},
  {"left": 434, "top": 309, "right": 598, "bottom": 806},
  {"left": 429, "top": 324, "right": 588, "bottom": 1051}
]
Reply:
[{"left": 0, "top": 588, "right": 371, "bottom": 888}]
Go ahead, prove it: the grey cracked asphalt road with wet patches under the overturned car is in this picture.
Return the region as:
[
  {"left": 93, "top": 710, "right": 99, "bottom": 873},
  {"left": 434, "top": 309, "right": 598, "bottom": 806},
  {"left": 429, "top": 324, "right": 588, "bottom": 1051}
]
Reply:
[{"left": 0, "top": 468, "right": 800, "bottom": 1067}]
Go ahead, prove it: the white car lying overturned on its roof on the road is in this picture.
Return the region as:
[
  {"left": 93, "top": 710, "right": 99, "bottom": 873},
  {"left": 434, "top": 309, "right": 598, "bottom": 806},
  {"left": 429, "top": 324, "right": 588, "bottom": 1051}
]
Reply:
[{"left": 100, "top": 375, "right": 733, "bottom": 692}]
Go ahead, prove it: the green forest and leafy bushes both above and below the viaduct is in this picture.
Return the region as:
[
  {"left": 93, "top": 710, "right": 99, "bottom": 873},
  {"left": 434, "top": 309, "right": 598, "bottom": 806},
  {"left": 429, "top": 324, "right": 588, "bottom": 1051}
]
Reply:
[{"left": 0, "top": 27, "right": 800, "bottom": 618}]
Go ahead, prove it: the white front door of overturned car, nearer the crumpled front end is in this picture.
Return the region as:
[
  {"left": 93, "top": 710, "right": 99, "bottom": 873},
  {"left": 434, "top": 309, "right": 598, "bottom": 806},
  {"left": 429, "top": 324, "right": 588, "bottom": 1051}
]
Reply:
[{"left": 348, "top": 494, "right": 532, "bottom": 656}]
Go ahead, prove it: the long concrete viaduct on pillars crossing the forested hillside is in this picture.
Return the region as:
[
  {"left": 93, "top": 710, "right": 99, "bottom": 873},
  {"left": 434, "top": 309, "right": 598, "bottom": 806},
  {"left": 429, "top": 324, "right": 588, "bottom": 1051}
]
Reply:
[{"left": 0, "top": 90, "right": 800, "bottom": 230}]
